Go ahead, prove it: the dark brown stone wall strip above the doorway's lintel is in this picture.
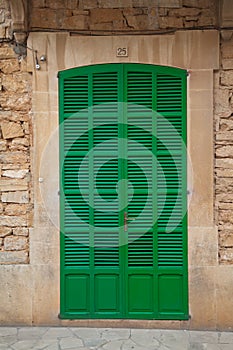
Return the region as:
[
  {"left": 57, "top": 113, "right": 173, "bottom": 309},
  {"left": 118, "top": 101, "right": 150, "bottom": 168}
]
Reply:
[{"left": 30, "top": 0, "right": 217, "bottom": 31}]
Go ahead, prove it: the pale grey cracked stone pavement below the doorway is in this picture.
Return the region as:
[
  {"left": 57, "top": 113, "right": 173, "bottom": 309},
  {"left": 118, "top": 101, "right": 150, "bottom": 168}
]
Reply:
[{"left": 0, "top": 327, "right": 233, "bottom": 350}]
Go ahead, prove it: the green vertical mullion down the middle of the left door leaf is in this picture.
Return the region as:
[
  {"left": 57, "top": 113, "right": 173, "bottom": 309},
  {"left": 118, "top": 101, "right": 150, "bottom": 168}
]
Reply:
[{"left": 88, "top": 73, "right": 95, "bottom": 316}]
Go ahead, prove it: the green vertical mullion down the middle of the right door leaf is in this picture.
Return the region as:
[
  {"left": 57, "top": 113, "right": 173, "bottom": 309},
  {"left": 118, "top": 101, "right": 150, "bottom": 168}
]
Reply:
[{"left": 152, "top": 72, "right": 158, "bottom": 318}]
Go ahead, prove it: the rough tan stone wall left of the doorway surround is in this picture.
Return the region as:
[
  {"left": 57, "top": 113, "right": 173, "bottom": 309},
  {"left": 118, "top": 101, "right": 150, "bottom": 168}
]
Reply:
[{"left": 0, "top": 1, "right": 32, "bottom": 264}]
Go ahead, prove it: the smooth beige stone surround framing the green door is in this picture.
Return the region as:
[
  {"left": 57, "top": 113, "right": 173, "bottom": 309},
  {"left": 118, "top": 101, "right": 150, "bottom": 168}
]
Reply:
[{"left": 2, "top": 30, "right": 230, "bottom": 329}]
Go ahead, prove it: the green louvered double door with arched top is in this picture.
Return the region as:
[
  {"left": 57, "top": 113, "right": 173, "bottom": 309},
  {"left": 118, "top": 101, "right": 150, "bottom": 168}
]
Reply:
[{"left": 59, "top": 64, "right": 188, "bottom": 319}]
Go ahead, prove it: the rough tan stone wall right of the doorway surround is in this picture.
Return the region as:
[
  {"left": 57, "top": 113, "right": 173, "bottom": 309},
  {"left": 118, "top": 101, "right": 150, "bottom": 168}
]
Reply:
[{"left": 215, "top": 32, "right": 233, "bottom": 264}]
